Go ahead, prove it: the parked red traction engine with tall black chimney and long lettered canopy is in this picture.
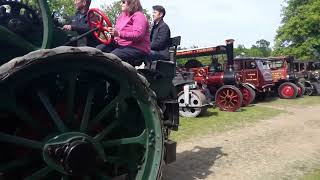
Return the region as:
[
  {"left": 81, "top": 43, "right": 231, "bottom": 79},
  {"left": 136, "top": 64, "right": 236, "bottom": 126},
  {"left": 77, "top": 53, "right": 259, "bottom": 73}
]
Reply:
[{"left": 177, "top": 40, "right": 254, "bottom": 111}]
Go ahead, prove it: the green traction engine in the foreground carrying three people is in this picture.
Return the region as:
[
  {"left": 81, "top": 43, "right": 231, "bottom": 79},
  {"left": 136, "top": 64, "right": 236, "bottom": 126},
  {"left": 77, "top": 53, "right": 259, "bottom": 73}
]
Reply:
[{"left": 0, "top": 0, "right": 180, "bottom": 180}]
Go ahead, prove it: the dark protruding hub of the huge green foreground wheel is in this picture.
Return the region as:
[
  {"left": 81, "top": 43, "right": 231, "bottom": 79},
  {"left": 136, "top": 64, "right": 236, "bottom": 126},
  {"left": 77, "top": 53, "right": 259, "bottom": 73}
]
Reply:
[{"left": 43, "top": 134, "right": 102, "bottom": 176}]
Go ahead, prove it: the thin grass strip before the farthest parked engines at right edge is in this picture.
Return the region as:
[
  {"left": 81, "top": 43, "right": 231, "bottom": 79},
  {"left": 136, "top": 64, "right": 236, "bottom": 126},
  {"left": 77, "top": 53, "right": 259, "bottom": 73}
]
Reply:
[{"left": 261, "top": 96, "right": 320, "bottom": 107}]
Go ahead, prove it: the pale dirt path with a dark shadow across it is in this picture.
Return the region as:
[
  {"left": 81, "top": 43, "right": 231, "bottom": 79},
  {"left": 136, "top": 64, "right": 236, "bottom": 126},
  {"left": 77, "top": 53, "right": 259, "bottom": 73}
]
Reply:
[{"left": 163, "top": 106, "right": 320, "bottom": 180}]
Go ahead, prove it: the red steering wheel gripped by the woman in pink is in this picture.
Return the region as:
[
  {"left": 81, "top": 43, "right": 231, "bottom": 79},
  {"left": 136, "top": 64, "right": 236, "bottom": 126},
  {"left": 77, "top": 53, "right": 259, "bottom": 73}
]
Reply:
[{"left": 87, "top": 8, "right": 112, "bottom": 45}]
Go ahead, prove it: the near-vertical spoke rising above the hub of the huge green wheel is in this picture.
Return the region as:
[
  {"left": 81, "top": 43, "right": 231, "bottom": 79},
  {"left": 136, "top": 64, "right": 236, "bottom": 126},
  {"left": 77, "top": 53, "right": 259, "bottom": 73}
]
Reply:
[{"left": 67, "top": 73, "right": 78, "bottom": 122}]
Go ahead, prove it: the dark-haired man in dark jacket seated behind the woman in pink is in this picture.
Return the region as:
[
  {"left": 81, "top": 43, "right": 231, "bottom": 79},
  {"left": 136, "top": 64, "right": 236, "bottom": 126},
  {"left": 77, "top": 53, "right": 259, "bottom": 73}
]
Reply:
[{"left": 150, "top": 5, "right": 170, "bottom": 61}]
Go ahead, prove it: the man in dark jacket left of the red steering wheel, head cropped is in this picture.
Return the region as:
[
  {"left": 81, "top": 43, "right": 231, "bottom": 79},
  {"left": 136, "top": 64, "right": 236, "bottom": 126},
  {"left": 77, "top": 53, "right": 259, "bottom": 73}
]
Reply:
[{"left": 62, "top": 0, "right": 99, "bottom": 47}]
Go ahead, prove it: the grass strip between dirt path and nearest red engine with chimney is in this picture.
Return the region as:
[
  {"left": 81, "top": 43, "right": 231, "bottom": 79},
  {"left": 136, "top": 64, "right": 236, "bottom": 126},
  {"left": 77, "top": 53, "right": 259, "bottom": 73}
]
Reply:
[{"left": 170, "top": 106, "right": 285, "bottom": 141}]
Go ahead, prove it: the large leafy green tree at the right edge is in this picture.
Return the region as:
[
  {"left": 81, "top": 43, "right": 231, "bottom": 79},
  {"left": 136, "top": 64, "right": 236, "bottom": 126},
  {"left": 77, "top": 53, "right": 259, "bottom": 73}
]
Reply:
[{"left": 274, "top": 0, "right": 320, "bottom": 60}]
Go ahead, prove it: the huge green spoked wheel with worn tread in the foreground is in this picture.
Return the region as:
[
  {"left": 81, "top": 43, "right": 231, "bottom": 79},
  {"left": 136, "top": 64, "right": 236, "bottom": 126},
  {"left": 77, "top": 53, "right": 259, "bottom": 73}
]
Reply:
[{"left": 0, "top": 47, "right": 163, "bottom": 180}]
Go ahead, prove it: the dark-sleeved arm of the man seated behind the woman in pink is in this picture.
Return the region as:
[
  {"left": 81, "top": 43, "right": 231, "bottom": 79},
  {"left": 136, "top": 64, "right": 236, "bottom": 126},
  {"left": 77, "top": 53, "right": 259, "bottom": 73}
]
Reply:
[{"left": 151, "top": 25, "right": 170, "bottom": 51}]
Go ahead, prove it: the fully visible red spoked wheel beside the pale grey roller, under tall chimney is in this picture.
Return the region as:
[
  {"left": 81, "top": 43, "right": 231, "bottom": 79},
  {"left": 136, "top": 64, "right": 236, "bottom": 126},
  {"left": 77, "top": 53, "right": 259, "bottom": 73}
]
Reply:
[{"left": 215, "top": 85, "right": 243, "bottom": 112}]
